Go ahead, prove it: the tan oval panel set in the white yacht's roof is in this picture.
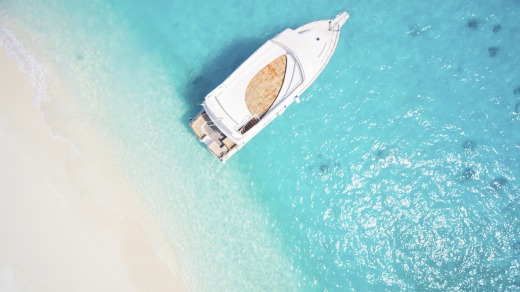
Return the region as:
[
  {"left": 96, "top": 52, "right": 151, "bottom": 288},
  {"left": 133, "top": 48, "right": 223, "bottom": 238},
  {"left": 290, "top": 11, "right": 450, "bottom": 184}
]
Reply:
[{"left": 246, "top": 55, "right": 287, "bottom": 118}]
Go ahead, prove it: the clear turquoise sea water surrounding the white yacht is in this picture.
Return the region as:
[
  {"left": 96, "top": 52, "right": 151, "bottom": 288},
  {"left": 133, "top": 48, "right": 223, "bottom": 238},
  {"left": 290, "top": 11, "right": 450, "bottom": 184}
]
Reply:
[{"left": 0, "top": 0, "right": 520, "bottom": 291}]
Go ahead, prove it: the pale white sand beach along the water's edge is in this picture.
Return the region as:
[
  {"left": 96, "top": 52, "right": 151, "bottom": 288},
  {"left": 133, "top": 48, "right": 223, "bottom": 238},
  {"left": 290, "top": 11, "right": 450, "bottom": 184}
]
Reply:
[{"left": 0, "top": 47, "right": 185, "bottom": 291}]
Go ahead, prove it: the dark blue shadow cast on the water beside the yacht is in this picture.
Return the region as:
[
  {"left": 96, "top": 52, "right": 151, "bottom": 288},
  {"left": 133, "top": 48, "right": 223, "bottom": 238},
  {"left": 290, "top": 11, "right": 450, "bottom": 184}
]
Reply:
[{"left": 181, "top": 39, "right": 265, "bottom": 128}]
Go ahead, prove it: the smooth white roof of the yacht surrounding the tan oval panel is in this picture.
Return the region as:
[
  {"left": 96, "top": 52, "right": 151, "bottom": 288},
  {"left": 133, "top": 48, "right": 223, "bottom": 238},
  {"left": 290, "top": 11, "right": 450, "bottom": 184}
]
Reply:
[{"left": 203, "top": 29, "right": 317, "bottom": 139}]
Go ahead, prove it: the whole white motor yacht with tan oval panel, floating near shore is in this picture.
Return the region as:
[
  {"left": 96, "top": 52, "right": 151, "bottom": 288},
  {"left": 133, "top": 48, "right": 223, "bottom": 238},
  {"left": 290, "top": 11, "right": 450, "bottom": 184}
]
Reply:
[{"left": 190, "top": 12, "right": 349, "bottom": 162}]
